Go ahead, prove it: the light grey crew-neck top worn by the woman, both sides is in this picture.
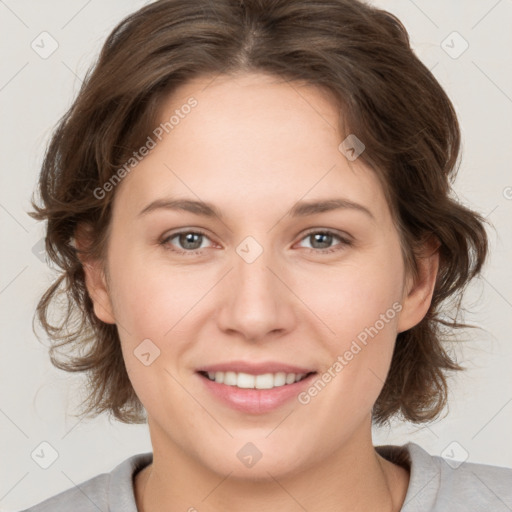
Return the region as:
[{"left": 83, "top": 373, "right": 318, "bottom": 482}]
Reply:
[{"left": 22, "top": 443, "right": 512, "bottom": 512}]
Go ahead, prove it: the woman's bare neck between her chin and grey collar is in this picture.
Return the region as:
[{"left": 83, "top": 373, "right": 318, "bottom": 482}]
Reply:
[{"left": 134, "top": 420, "right": 409, "bottom": 512}]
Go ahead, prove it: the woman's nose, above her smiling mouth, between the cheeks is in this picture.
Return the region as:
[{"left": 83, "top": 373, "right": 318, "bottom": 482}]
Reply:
[{"left": 217, "top": 244, "right": 299, "bottom": 342}]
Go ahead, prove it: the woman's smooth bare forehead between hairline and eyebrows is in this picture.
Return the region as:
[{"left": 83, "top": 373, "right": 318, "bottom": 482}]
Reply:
[{"left": 111, "top": 73, "right": 387, "bottom": 223}]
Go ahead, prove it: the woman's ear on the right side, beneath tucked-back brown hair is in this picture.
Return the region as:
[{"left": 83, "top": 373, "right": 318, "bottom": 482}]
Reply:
[{"left": 397, "top": 236, "right": 440, "bottom": 332}]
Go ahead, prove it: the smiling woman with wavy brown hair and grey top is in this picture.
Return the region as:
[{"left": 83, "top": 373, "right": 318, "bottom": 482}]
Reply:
[{"left": 22, "top": 0, "right": 512, "bottom": 512}]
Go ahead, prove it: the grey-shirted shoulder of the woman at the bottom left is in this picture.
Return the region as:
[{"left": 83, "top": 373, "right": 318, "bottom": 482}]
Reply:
[{"left": 21, "top": 452, "right": 153, "bottom": 512}]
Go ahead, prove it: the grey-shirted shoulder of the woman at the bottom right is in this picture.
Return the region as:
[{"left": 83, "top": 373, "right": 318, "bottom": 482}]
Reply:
[{"left": 377, "top": 443, "right": 512, "bottom": 512}]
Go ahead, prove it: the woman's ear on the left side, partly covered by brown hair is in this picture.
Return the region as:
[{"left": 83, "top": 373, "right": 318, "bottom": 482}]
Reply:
[{"left": 74, "top": 224, "right": 116, "bottom": 324}]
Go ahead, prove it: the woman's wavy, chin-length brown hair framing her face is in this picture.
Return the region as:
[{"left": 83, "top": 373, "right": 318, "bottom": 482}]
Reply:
[{"left": 29, "top": 0, "right": 488, "bottom": 424}]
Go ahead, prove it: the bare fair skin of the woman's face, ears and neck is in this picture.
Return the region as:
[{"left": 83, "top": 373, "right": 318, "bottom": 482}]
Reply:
[{"left": 77, "top": 73, "right": 438, "bottom": 512}]
